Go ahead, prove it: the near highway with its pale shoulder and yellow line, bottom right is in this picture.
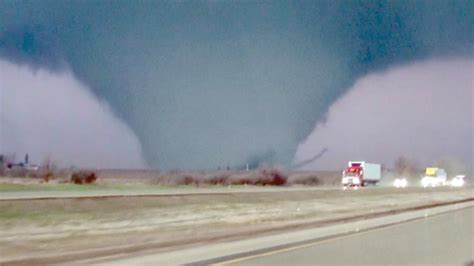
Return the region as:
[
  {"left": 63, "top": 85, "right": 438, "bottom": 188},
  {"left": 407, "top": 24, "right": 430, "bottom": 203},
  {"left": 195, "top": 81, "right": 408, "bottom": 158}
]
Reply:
[{"left": 79, "top": 200, "right": 474, "bottom": 266}]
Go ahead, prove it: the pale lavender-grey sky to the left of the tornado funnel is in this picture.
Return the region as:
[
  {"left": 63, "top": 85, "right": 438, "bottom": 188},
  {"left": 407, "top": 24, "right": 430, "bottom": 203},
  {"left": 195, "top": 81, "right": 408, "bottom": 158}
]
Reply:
[{"left": 0, "top": 60, "right": 147, "bottom": 168}]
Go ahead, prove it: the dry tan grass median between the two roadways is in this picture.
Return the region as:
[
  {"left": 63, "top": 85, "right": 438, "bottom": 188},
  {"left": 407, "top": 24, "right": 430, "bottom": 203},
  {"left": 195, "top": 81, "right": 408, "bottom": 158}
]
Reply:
[{"left": 0, "top": 185, "right": 474, "bottom": 264}]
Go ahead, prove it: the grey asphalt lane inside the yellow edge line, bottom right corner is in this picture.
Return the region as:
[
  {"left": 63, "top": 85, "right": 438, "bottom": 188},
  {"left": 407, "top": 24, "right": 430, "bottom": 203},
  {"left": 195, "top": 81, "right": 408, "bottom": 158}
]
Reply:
[{"left": 215, "top": 207, "right": 474, "bottom": 265}]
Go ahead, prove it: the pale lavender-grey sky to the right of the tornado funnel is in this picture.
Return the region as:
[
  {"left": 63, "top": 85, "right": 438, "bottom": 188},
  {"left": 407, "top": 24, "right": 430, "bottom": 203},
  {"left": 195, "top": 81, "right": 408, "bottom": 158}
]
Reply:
[{"left": 295, "top": 59, "right": 474, "bottom": 169}]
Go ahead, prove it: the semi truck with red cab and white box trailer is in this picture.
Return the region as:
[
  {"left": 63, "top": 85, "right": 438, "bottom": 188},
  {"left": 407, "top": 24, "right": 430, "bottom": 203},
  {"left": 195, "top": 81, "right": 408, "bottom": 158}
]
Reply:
[{"left": 341, "top": 161, "right": 382, "bottom": 188}]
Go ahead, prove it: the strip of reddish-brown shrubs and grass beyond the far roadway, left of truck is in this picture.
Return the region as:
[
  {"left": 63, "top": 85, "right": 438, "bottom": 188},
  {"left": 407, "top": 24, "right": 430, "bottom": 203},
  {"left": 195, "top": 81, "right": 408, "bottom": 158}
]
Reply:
[{"left": 0, "top": 167, "right": 340, "bottom": 192}]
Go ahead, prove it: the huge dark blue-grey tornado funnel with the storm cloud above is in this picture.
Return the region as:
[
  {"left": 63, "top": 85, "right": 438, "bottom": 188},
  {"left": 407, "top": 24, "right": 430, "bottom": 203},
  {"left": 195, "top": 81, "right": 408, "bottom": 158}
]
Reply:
[{"left": 0, "top": 1, "right": 474, "bottom": 168}]
